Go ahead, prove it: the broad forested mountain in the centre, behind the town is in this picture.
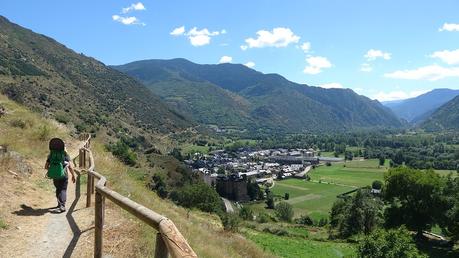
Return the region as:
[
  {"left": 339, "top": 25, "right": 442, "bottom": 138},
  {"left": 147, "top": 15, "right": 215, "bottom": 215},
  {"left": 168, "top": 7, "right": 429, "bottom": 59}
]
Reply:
[{"left": 113, "top": 59, "right": 401, "bottom": 131}]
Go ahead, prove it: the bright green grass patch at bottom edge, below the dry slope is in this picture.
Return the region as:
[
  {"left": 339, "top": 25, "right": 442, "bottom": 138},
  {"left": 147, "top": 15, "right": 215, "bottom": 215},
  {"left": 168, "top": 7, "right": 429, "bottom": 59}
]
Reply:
[{"left": 244, "top": 230, "right": 356, "bottom": 258}]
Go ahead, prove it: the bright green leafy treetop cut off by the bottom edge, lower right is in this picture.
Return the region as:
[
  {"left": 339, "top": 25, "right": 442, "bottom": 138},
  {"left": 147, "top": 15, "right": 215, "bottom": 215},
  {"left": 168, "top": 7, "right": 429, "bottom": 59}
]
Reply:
[{"left": 358, "top": 228, "right": 426, "bottom": 258}]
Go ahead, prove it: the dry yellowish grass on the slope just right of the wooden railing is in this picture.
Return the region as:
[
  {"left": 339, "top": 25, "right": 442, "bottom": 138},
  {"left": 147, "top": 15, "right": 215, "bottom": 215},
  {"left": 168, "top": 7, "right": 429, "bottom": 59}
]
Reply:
[{"left": 92, "top": 139, "right": 270, "bottom": 257}]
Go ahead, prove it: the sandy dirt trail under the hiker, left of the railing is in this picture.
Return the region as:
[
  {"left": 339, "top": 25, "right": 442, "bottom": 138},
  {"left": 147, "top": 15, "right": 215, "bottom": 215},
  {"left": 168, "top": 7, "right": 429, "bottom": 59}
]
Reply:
[{"left": 0, "top": 141, "right": 93, "bottom": 257}]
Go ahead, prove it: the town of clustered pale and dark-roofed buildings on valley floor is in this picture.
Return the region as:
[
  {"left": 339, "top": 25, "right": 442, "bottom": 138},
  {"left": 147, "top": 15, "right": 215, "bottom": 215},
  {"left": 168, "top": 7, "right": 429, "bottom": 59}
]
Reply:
[{"left": 185, "top": 148, "right": 319, "bottom": 201}]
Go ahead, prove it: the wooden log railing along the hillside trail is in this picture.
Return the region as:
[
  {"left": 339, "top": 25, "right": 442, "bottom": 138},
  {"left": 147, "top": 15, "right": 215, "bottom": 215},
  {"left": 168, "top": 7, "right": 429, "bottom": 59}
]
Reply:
[{"left": 78, "top": 135, "right": 197, "bottom": 258}]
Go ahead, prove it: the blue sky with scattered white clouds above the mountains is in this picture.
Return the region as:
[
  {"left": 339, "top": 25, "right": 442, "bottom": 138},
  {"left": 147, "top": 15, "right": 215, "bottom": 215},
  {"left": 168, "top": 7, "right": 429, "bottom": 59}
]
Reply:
[{"left": 0, "top": 0, "right": 459, "bottom": 100}]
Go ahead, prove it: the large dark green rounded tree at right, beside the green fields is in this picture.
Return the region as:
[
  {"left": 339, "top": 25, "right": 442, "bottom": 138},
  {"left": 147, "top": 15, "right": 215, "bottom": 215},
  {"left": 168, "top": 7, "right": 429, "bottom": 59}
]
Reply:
[{"left": 384, "top": 167, "right": 442, "bottom": 236}]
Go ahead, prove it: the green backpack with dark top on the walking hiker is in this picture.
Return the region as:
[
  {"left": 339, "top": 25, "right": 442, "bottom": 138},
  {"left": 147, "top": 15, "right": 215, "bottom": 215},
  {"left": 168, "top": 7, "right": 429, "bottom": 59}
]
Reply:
[{"left": 47, "top": 138, "right": 65, "bottom": 179}]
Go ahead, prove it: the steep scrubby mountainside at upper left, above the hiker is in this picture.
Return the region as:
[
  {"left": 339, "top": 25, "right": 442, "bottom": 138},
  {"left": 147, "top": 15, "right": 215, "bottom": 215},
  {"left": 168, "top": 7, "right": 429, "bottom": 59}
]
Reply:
[{"left": 0, "top": 16, "right": 193, "bottom": 136}]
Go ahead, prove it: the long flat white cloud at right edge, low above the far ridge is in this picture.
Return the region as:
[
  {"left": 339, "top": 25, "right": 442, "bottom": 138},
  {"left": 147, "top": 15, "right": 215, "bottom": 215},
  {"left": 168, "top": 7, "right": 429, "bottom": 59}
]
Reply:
[{"left": 384, "top": 64, "right": 459, "bottom": 81}]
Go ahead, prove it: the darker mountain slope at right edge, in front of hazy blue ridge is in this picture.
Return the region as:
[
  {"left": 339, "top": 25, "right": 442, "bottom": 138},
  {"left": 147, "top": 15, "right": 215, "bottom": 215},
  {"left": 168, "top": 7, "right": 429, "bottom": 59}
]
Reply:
[{"left": 421, "top": 96, "right": 459, "bottom": 131}]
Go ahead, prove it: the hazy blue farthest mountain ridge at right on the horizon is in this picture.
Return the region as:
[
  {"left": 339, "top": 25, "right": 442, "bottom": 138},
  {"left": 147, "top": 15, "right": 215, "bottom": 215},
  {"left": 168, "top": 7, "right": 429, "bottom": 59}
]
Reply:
[{"left": 383, "top": 89, "right": 459, "bottom": 123}]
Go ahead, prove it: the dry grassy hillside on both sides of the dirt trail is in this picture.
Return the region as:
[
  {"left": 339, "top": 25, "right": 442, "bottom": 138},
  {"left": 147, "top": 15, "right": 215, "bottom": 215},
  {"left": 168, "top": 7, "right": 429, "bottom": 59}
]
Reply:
[{"left": 0, "top": 95, "right": 270, "bottom": 257}]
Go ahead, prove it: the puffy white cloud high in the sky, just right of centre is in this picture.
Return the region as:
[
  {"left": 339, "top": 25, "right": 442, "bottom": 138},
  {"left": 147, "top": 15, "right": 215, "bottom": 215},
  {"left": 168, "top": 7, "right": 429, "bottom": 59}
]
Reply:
[{"left": 241, "top": 27, "right": 300, "bottom": 50}]
